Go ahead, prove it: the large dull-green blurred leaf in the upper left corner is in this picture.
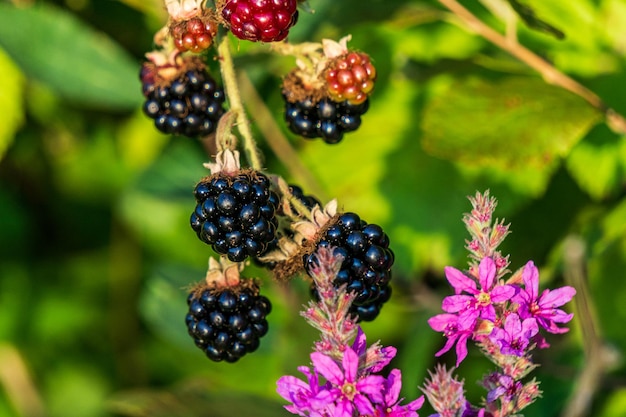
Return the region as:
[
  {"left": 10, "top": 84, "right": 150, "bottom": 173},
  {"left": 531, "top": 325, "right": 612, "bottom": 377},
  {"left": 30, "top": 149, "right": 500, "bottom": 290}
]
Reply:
[{"left": 0, "top": 3, "right": 142, "bottom": 109}]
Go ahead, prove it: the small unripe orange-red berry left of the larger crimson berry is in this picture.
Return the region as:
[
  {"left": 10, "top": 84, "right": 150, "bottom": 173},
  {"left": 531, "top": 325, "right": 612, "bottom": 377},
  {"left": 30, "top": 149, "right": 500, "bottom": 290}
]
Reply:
[{"left": 170, "top": 16, "right": 217, "bottom": 52}]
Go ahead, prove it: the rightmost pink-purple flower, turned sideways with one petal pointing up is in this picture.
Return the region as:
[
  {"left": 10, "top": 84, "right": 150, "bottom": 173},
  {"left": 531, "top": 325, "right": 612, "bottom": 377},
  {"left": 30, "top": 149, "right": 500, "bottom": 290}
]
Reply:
[{"left": 512, "top": 261, "right": 576, "bottom": 334}]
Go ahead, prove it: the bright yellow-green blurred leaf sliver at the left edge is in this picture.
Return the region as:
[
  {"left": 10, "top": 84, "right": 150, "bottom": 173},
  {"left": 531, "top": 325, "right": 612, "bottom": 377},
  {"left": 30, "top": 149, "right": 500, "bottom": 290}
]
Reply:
[{"left": 0, "top": 46, "right": 24, "bottom": 159}]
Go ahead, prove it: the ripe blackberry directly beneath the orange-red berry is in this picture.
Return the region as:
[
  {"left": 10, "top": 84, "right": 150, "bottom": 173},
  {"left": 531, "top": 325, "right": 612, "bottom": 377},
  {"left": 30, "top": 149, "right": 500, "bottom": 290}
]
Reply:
[{"left": 283, "top": 95, "right": 369, "bottom": 144}]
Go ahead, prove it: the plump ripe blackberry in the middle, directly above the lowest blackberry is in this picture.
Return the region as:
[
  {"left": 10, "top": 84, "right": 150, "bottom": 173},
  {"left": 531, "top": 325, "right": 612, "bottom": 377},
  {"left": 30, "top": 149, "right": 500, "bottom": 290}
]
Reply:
[{"left": 190, "top": 171, "right": 279, "bottom": 262}]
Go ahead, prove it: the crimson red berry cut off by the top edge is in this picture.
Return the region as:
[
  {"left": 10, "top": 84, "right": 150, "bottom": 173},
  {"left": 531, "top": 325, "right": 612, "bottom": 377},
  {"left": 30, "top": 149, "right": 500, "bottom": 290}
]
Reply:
[{"left": 218, "top": 0, "right": 298, "bottom": 42}]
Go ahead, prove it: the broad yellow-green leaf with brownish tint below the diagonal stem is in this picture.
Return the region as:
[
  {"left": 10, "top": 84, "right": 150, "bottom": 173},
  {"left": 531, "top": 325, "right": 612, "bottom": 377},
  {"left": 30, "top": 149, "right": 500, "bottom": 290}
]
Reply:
[{"left": 422, "top": 77, "right": 600, "bottom": 171}]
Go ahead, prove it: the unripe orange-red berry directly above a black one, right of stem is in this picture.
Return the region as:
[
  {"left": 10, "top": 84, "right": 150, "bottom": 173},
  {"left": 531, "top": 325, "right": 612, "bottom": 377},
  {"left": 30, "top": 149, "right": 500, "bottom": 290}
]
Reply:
[{"left": 324, "top": 51, "right": 376, "bottom": 104}]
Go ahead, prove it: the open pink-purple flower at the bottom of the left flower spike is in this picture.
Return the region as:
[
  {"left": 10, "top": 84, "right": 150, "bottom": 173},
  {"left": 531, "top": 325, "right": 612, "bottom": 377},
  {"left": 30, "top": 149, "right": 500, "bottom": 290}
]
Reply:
[{"left": 311, "top": 347, "right": 385, "bottom": 417}]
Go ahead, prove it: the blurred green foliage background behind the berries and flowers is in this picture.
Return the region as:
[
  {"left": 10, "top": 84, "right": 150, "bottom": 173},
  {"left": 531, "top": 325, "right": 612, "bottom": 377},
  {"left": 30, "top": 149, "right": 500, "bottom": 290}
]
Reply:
[{"left": 0, "top": 0, "right": 626, "bottom": 417}]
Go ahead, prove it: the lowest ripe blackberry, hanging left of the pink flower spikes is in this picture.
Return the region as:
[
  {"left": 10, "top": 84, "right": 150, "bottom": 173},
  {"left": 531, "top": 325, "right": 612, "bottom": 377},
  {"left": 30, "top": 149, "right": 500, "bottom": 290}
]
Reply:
[{"left": 185, "top": 286, "right": 272, "bottom": 363}]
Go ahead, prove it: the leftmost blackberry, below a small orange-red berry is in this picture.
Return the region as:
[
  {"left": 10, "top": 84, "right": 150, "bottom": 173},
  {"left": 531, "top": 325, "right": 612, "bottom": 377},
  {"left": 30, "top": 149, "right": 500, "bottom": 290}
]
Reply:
[{"left": 141, "top": 66, "right": 225, "bottom": 137}]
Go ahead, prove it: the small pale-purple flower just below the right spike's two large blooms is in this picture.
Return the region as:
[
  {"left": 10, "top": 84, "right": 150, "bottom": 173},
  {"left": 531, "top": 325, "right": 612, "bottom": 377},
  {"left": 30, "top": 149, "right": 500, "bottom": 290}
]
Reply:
[{"left": 489, "top": 313, "right": 539, "bottom": 356}]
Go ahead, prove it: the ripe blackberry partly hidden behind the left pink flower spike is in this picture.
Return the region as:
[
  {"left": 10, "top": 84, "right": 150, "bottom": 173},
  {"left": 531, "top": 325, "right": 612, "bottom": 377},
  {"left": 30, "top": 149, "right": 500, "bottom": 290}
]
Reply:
[{"left": 303, "top": 213, "right": 394, "bottom": 321}]
